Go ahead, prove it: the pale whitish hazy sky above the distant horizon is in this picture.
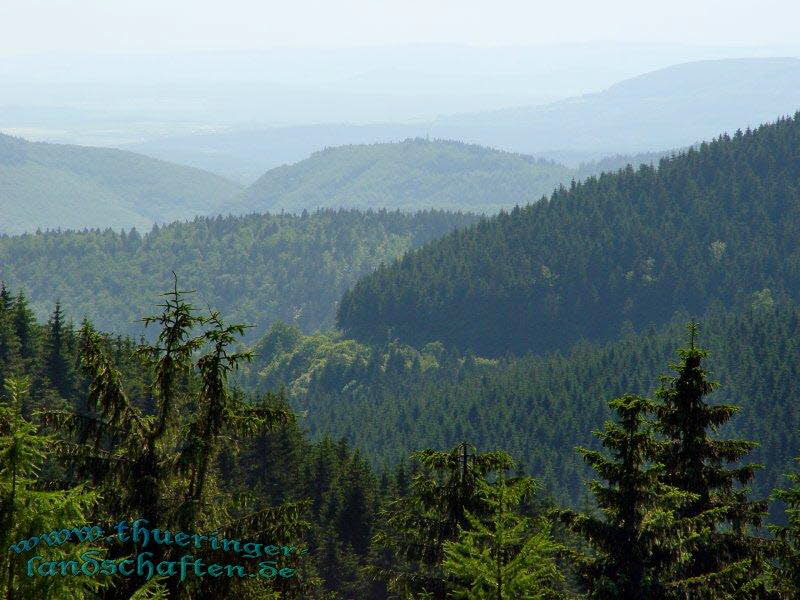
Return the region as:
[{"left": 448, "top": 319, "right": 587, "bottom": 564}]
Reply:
[{"left": 0, "top": 0, "right": 800, "bottom": 56}]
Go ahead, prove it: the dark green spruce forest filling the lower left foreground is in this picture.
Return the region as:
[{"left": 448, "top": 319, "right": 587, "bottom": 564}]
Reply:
[{"left": 0, "top": 288, "right": 394, "bottom": 600}]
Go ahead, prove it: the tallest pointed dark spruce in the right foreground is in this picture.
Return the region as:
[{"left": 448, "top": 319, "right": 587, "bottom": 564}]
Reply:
[{"left": 655, "top": 323, "right": 769, "bottom": 599}]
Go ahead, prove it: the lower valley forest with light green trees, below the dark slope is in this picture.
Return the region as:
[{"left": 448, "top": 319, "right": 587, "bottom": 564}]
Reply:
[{"left": 243, "top": 300, "right": 800, "bottom": 520}]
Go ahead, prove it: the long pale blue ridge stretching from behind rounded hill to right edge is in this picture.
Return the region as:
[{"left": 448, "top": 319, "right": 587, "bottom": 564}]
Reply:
[{"left": 125, "top": 58, "right": 800, "bottom": 183}]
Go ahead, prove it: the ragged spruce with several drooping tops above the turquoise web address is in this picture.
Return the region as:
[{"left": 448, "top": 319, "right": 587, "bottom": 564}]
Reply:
[{"left": 47, "top": 283, "right": 307, "bottom": 600}]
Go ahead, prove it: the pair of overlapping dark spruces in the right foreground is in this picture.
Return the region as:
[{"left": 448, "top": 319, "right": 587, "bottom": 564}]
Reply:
[{"left": 561, "top": 332, "right": 776, "bottom": 600}]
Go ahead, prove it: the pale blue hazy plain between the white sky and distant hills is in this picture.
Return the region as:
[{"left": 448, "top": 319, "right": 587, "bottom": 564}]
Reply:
[{"left": 7, "top": 42, "right": 800, "bottom": 150}]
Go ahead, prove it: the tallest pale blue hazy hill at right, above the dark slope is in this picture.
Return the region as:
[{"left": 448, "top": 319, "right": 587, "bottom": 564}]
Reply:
[{"left": 430, "top": 58, "right": 800, "bottom": 161}]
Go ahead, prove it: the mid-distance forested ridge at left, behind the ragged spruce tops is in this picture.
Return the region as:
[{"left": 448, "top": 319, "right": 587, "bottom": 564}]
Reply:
[{"left": 0, "top": 211, "right": 475, "bottom": 334}]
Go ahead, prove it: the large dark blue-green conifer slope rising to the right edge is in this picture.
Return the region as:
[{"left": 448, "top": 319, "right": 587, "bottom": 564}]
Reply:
[{"left": 338, "top": 113, "right": 800, "bottom": 355}]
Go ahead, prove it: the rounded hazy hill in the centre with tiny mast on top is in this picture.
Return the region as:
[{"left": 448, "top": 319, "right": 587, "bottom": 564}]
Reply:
[{"left": 225, "top": 138, "right": 575, "bottom": 213}]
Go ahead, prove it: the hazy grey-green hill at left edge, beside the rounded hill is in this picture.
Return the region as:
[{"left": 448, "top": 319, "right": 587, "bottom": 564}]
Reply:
[{"left": 0, "top": 134, "right": 240, "bottom": 234}]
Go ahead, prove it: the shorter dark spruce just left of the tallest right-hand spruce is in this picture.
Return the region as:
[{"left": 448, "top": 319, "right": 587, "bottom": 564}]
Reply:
[{"left": 557, "top": 395, "right": 692, "bottom": 600}]
